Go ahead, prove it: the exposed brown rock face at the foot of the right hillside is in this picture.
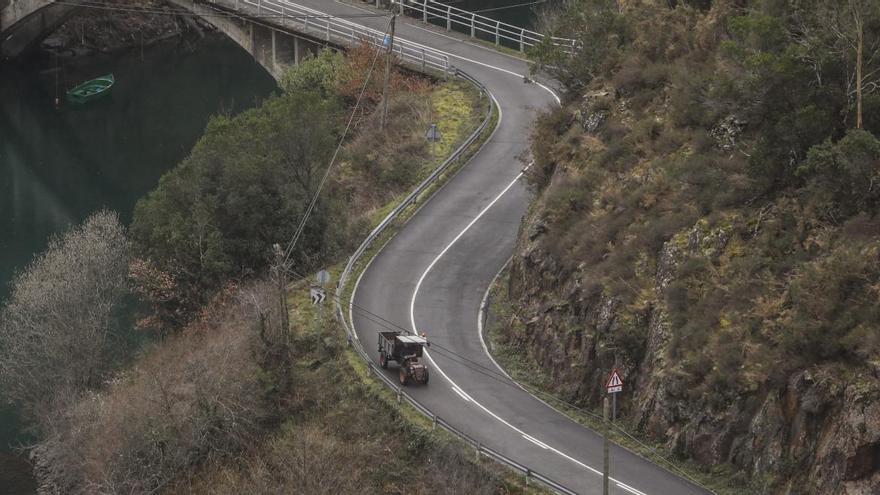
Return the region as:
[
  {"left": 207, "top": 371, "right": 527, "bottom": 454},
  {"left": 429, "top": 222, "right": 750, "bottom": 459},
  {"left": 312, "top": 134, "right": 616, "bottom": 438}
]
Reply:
[{"left": 507, "top": 203, "right": 880, "bottom": 495}]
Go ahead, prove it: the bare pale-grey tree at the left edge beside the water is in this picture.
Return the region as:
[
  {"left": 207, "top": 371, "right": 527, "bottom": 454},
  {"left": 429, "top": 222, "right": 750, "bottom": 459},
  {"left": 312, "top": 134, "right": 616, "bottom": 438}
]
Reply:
[{"left": 0, "top": 211, "right": 129, "bottom": 428}]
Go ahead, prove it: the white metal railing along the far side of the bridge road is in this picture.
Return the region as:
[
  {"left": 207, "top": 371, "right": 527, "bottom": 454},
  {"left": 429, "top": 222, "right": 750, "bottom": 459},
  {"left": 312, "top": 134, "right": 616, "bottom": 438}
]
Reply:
[{"left": 388, "top": 0, "right": 576, "bottom": 52}]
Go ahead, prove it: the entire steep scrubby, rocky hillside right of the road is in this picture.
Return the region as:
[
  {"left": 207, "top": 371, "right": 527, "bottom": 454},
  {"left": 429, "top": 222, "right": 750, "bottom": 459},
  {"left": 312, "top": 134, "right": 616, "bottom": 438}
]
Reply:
[{"left": 488, "top": 0, "right": 880, "bottom": 494}]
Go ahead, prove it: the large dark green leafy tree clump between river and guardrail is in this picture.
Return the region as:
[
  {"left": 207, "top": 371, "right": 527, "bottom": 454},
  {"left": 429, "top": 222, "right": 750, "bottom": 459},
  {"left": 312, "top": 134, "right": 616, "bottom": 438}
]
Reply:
[{"left": 131, "top": 90, "right": 344, "bottom": 332}]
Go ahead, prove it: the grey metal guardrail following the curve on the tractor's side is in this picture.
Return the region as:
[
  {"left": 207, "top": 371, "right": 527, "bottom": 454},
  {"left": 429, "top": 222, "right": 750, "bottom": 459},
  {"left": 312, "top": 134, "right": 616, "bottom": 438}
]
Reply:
[{"left": 335, "top": 62, "right": 577, "bottom": 495}]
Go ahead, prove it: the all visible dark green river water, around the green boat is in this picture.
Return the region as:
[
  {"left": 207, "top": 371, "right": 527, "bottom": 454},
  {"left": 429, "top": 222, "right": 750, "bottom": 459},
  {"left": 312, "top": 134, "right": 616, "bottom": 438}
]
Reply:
[{"left": 0, "top": 0, "right": 544, "bottom": 495}]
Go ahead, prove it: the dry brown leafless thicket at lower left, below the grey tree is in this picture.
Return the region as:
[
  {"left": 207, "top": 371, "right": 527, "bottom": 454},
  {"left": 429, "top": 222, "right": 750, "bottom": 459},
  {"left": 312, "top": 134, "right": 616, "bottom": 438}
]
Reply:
[{"left": 37, "top": 283, "right": 286, "bottom": 493}]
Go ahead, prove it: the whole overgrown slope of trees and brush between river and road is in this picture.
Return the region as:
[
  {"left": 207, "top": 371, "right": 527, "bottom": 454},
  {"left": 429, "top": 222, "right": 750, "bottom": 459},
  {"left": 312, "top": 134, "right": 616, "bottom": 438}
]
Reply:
[{"left": 0, "top": 48, "right": 506, "bottom": 494}]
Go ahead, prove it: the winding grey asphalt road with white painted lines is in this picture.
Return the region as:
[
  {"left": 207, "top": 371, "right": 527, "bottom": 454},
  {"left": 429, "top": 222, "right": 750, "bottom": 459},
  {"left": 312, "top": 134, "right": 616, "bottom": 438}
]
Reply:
[{"left": 297, "top": 0, "right": 708, "bottom": 495}]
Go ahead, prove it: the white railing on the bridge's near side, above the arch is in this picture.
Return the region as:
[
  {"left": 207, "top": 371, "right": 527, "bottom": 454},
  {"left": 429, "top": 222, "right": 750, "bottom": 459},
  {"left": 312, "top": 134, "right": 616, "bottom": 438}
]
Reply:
[{"left": 235, "top": 0, "right": 452, "bottom": 76}]
